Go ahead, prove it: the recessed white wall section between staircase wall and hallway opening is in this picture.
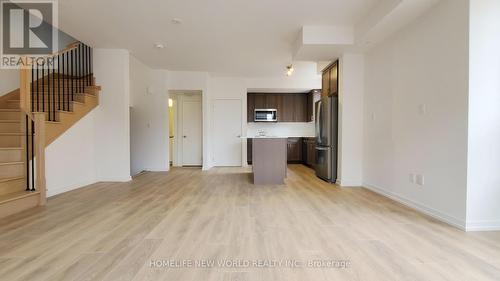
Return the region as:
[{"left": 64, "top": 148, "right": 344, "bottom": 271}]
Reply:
[{"left": 130, "top": 56, "right": 169, "bottom": 175}]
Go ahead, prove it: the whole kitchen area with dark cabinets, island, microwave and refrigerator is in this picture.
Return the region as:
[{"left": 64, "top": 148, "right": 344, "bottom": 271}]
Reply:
[{"left": 246, "top": 61, "right": 338, "bottom": 184}]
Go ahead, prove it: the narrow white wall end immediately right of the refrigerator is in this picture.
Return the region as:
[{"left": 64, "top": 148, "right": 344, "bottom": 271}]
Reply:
[{"left": 337, "top": 54, "right": 365, "bottom": 186}]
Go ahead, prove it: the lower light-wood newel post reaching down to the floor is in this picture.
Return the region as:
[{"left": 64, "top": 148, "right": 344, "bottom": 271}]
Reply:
[{"left": 33, "top": 112, "right": 47, "bottom": 205}]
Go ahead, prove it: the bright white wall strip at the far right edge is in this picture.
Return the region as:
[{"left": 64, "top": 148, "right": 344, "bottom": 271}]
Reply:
[{"left": 467, "top": 0, "right": 500, "bottom": 230}]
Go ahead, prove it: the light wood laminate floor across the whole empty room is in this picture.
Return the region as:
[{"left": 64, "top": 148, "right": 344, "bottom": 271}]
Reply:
[{"left": 0, "top": 165, "right": 500, "bottom": 281}]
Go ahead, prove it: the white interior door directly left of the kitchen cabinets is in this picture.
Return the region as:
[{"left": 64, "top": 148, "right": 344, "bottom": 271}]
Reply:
[{"left": 213, "top": 99, "right": 242, "bottom": 166}]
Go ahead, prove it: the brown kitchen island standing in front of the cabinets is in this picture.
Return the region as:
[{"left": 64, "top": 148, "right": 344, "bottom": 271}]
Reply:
[{"left": 252, "top": 137, "right": 287, "bottom": 185}]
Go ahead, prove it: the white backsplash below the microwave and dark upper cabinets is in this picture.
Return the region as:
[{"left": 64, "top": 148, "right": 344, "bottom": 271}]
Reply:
[{"left": 247, "top": 122, "right": 315, "bottom": 137}]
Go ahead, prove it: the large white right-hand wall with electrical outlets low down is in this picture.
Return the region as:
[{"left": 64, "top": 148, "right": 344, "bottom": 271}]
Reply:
[{"left": 363, "top": 0, "right": 468, "bottom": 228}]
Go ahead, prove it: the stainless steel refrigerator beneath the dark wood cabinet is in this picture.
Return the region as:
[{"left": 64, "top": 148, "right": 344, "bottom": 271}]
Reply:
[{"left": 315, "top": 96, "right": 339, "bottom": 183}]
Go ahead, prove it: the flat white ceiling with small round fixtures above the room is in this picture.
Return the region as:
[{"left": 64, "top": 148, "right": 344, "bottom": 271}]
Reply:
[{"left": 59, "top": 0, "right": 378, "bottom": 76}]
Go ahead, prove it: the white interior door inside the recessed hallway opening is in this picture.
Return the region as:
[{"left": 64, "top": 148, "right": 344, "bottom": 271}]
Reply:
[{"left": 182, "top": 100, "right": 202, "bottom": 166}]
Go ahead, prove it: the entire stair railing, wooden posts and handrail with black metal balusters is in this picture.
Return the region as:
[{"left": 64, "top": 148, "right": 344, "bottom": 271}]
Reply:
[{"left": 19, "top": 41, "right": 93, "bottom": 205}]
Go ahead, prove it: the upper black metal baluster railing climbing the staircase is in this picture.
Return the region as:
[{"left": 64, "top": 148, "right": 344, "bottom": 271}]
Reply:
[{"left": 31, "top": 42, "right": 93, "bottom": 121}]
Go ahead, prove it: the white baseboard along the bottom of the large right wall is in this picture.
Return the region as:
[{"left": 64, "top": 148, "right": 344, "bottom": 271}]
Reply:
[{"left": 363, "top": 183, "right": 467, "bottom": 231}]
